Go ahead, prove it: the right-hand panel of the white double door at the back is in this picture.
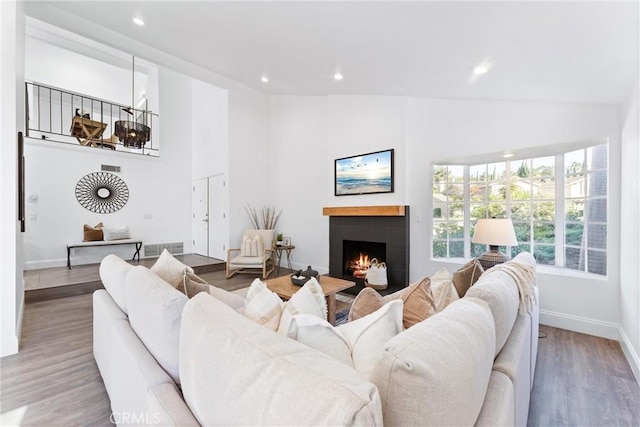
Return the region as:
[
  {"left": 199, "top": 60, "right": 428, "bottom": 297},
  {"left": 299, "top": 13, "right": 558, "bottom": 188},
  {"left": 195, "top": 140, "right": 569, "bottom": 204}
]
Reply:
[{"left": 209, "top": 175, "right": 229, "bottom": 260}]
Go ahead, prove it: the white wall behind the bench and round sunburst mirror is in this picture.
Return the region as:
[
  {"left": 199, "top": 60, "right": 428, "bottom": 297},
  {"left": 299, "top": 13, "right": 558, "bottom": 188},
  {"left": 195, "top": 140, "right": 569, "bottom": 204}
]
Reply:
[{"left": 25, "top": 70, "right": 191, "bottom": 269}]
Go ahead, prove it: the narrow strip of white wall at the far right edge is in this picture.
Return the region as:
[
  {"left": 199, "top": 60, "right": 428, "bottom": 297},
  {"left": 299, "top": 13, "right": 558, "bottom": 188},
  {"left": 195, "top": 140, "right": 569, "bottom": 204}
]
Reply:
[{"left": 619, "top": 77, "right": 640, "bottom": 380}]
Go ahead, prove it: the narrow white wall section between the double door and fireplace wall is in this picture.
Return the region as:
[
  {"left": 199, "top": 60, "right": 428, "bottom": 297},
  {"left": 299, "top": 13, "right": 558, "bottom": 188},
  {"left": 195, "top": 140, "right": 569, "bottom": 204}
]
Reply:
[{"left": 229, "top": 89, "right": 270, "bottom": 248}]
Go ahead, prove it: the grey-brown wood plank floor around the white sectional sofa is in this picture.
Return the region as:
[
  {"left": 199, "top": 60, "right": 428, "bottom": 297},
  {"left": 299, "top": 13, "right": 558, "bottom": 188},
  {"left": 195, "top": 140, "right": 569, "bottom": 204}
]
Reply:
[{"left": 5, "top": 262, "right": 640, "bottom": 426}]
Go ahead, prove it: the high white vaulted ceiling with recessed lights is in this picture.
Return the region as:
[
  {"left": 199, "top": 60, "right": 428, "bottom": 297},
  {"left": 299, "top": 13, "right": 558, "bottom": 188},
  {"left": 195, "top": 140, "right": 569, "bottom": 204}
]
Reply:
[{"left": 26, "top": 1, "right": 640, "bottom": 103}]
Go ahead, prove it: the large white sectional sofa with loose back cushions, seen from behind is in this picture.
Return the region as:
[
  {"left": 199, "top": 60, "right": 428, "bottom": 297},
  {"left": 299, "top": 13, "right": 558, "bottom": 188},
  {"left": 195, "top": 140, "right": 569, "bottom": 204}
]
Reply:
[{"left": 94, "top": 253, "right": 538, "bottom": 426}]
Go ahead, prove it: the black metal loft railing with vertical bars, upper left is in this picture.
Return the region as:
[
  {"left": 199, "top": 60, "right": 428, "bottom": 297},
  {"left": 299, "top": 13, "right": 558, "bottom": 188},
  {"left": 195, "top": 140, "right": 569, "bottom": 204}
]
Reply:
[{"left": 25, "top": 82, "right": 160, "bottom": 156}]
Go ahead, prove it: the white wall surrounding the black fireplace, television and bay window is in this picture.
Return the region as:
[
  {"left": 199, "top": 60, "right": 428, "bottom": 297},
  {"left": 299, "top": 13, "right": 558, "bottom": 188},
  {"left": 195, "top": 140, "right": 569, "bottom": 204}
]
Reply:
[{"left": 272, "top": 96, "right": 620, "bottom": 339}]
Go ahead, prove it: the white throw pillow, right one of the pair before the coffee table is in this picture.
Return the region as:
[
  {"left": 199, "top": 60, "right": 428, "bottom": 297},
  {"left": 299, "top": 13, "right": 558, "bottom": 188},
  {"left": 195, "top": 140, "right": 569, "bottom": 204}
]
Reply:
[{"left": 278, "top": 277, "right": 327, "bottom": 335}]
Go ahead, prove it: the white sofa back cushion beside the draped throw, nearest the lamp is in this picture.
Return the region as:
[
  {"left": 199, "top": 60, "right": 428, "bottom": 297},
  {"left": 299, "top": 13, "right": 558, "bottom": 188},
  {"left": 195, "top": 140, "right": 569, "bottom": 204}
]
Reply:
[{"left": 466, "top": 270, "right": 520, "bottom": 356}]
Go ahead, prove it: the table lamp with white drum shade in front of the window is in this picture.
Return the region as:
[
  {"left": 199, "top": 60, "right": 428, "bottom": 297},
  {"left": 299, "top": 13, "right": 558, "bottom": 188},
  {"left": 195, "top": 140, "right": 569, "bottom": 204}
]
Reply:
[{"left": 471, "top": 218, "right": 518, "bottom": 270}]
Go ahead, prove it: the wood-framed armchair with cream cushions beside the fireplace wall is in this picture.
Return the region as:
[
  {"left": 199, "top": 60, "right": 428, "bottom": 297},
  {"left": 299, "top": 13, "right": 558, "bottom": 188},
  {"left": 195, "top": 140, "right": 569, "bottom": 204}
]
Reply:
[{"left": 227, "top": 230, "right": 275, "bottom": 279}]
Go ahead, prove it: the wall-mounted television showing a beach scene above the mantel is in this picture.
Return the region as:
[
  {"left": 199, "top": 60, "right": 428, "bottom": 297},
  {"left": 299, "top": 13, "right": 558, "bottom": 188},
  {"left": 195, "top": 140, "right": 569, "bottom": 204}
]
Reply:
[{"left": 335, "top": 149, "right": 393, "bottom": 196}]
